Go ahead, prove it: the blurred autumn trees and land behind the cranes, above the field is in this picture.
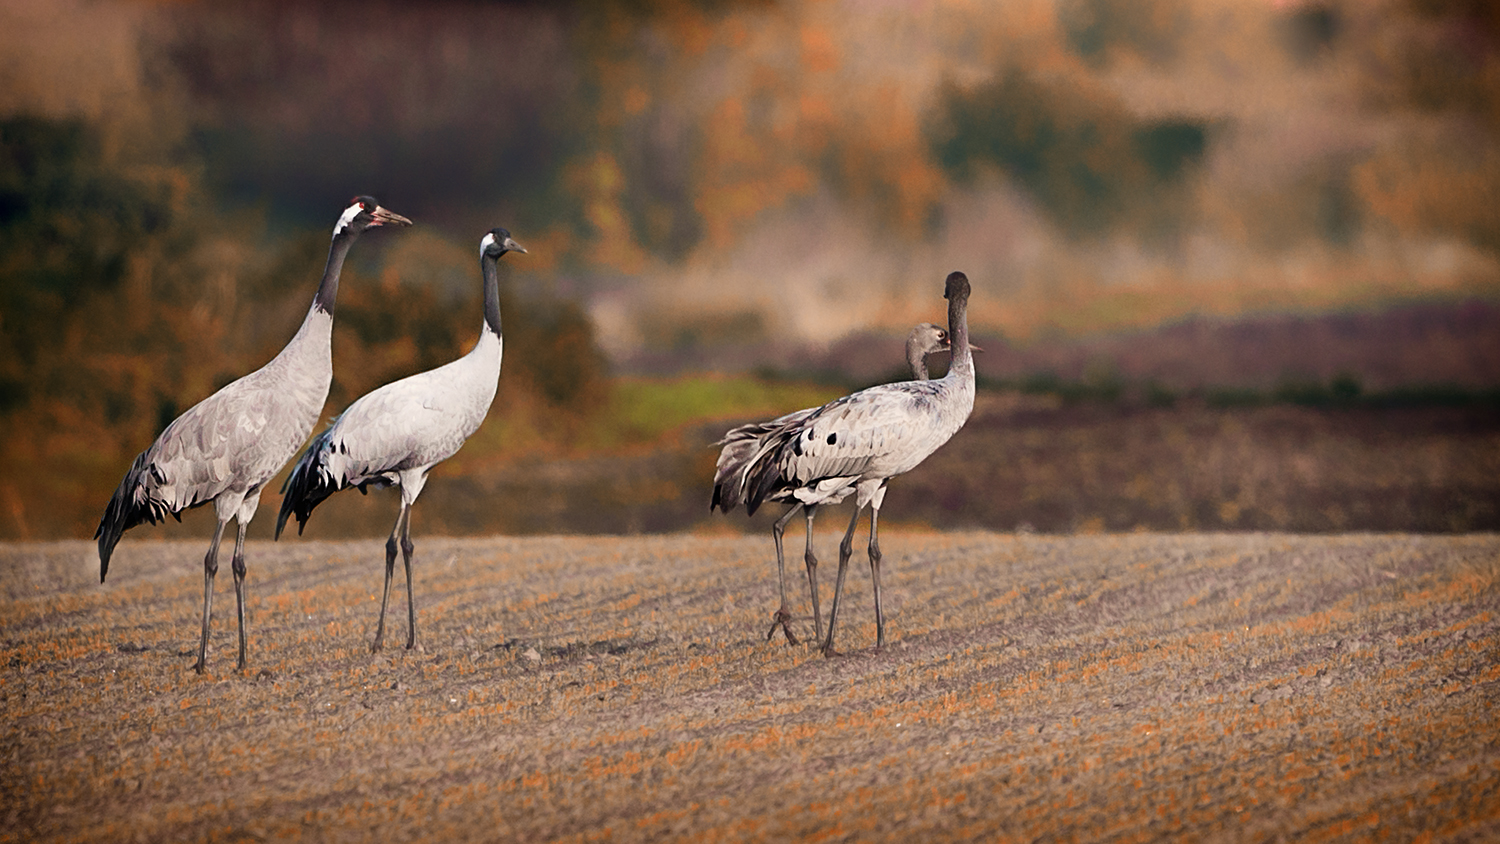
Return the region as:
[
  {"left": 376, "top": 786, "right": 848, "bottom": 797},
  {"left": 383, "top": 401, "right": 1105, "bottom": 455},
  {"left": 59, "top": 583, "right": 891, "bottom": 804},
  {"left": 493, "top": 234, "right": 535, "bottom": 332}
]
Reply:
[{"left": 0, "top": 0, "right": 1500, "bottom": 540}]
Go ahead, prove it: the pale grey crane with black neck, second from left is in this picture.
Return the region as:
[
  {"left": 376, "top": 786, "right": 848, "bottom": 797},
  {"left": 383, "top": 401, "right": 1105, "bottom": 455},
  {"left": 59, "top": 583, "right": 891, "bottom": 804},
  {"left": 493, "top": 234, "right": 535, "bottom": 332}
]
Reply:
[{"left": 276, "top": 228, "right": 525, "bottom": 651}]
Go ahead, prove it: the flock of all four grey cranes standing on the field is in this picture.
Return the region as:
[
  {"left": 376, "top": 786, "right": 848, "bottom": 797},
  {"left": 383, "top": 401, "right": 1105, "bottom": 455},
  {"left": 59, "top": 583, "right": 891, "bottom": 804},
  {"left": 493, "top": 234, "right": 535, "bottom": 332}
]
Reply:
[{"left": 95, "top": 196, "right": 980, "bottom": 673}]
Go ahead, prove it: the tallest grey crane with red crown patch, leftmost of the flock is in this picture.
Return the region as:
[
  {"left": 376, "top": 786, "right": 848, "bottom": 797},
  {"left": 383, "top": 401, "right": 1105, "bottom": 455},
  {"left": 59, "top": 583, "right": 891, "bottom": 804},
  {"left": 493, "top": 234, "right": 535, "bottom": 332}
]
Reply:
[{"left": 95, "top": 196, "right": 411, "bottom": 675}]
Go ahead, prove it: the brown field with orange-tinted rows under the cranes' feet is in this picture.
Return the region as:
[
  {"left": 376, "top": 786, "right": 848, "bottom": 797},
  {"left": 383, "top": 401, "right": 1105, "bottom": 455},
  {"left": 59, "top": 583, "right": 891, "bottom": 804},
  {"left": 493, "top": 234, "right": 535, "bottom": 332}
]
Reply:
[{"left": 0, "top": 530, "right": 1500, "bottom": 841}]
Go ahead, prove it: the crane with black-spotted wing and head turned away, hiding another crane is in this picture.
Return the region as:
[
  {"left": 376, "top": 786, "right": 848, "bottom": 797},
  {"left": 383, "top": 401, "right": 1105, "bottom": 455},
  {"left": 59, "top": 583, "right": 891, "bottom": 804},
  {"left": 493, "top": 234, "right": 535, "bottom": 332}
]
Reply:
[{"left": 731, "top": 273, "right": 974, "bottom": 657}]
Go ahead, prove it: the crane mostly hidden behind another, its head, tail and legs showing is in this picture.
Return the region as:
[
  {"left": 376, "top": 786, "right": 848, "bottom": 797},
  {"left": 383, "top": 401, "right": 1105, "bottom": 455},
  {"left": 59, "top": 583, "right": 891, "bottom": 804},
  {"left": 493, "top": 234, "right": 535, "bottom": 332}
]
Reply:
[{"left": 708, "top": 322, "right": 980, "bottom": 645}]
